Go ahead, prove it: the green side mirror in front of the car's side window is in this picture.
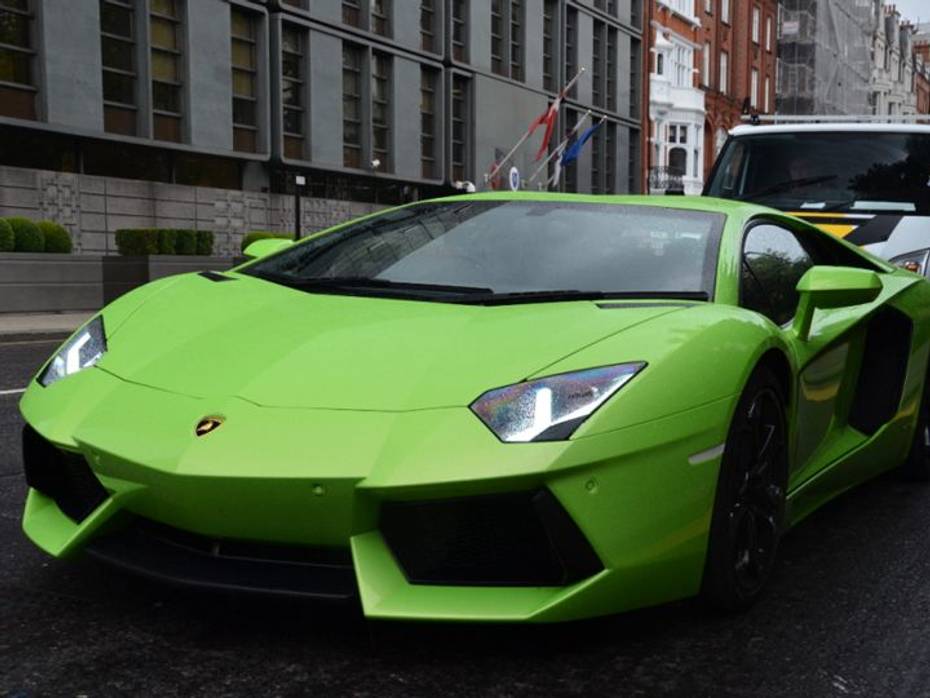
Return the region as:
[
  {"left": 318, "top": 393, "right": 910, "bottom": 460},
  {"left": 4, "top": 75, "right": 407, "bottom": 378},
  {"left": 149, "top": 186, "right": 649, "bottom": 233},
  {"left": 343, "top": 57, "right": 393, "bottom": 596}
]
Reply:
[{"left": 794, "top": 267, "right": 882, "bottom": 341}]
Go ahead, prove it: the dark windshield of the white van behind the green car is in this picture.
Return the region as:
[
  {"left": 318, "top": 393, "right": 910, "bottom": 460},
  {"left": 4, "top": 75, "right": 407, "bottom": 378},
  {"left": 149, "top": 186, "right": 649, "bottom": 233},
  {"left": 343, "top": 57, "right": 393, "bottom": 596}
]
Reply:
[{"left": 705, "top": 131, "right": 930, "bottom": 215}]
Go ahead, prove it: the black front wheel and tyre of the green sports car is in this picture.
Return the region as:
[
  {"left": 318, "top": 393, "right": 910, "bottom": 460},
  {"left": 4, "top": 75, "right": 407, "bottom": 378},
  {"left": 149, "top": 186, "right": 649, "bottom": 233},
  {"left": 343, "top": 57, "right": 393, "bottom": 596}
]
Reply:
[{"left": 701, "top": 367, "right": 788, "bottom": 611}]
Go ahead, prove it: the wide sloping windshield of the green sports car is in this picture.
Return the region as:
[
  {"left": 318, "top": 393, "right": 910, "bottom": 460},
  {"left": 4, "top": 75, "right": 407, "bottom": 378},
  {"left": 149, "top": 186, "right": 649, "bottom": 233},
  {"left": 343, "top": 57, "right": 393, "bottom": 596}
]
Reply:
[{"left": 243, "top": 200, "right": 724, "bottom": 302}]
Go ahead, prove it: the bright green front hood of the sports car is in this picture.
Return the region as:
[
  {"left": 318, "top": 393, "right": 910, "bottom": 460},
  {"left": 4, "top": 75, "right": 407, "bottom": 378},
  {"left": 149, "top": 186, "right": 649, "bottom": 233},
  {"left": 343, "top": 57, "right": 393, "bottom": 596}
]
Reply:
[{"left": 99, "top": 274, "right": 681, "bottom": 411}]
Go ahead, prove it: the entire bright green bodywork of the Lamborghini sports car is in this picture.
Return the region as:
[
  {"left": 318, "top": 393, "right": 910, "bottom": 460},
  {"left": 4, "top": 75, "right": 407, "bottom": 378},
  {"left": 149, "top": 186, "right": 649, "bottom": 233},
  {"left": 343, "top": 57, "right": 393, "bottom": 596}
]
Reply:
[{"left": 21, "top": 194, "right": 930, "bottom": 621}]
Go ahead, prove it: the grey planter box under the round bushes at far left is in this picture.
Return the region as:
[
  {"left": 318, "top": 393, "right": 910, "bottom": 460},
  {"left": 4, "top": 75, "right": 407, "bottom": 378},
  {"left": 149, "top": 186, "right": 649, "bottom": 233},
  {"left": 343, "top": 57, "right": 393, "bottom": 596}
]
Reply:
[{"left": 0, "top": 252, "right": 103, "bottom": 313}]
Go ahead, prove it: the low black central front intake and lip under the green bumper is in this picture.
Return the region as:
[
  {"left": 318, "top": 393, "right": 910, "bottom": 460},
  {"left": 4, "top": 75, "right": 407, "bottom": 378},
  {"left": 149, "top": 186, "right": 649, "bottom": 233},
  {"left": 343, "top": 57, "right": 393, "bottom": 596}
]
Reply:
[{"left": 86, "top": 517, "right": 357, "bottom": 601}]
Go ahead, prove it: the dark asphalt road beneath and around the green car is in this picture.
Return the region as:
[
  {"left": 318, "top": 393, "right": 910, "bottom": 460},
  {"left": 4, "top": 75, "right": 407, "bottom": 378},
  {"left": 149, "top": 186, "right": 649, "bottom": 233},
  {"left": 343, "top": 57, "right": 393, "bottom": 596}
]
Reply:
[{"left": 0, "top": 340, "right": 930, "bottom": 697}]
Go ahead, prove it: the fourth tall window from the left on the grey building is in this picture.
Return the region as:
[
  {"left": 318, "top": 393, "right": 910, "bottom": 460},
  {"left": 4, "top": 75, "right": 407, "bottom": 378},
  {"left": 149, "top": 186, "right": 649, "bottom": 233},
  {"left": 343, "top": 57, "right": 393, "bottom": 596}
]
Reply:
[{"left": 231, "top": 7, "right": 258, "bottom": 153}]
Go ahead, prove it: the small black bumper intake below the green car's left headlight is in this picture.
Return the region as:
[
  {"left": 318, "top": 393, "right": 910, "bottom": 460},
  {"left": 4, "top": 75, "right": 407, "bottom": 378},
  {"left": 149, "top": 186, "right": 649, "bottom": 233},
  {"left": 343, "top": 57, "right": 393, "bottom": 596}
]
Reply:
[{"left": 23, "top": 425, "right": 109, "bottom": 523}]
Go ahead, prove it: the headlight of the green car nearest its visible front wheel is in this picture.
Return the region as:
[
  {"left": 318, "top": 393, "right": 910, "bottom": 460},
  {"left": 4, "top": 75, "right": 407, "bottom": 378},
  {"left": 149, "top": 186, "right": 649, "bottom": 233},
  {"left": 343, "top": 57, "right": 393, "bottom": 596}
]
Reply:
[{"left": 471, "top": 362, "right": 646, "bottom": 443}]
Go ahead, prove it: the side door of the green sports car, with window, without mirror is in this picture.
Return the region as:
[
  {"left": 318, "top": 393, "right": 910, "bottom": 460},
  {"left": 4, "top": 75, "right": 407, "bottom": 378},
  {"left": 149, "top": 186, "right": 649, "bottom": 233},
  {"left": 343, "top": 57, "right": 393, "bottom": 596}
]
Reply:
[{"left": 740, "top": 221, "right": 865, "bottom": 485}]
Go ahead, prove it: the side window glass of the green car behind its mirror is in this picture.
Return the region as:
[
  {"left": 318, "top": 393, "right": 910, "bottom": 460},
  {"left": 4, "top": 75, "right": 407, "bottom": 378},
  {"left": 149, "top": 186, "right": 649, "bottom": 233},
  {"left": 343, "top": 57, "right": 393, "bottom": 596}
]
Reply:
[{"left": 740, "top": 223, "right": 814, "bottom": 325}]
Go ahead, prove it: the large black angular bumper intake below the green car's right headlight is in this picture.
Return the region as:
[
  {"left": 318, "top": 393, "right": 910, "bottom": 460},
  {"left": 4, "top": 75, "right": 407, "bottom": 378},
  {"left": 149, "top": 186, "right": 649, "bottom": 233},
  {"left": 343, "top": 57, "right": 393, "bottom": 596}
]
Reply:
[{"left": 380, "top": 489, "right": 603, "bottom": 586}]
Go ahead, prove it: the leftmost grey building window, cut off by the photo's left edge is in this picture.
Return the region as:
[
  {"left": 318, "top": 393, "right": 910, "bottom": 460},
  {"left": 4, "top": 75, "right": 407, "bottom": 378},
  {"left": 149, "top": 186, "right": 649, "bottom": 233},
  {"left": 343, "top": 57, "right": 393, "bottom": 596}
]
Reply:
[{"left": 0, "top": 0, "right": 36, "bottom": 119}]
